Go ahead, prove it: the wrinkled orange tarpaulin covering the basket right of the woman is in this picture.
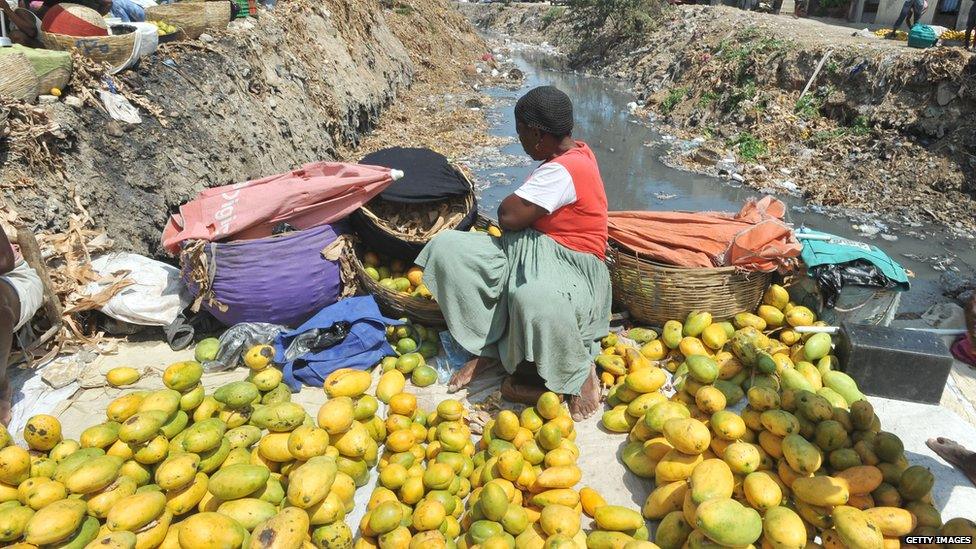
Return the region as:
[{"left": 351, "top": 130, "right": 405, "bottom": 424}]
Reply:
[{"left": 607, "top": 196, "right": 801, "bottom": 272}]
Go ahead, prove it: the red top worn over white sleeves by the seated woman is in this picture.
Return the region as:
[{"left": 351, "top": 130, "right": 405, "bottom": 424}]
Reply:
[{"left": 532, "top": 141, "right": 607, "bottom": 261}]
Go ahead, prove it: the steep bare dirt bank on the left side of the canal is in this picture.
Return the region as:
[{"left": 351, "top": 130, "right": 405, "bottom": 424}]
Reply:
[{"left": 0, "top": 0, "right": 483, "bottom": 254}]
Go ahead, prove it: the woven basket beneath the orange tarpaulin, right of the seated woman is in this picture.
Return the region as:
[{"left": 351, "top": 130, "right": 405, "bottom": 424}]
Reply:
[{"left": 607, "top": 242, "right": 773, "bottom": 326}]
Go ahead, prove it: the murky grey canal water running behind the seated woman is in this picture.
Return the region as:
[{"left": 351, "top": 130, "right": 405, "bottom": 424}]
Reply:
[{"left": 475, "top": 50, "right": 976, "bottom": 316}]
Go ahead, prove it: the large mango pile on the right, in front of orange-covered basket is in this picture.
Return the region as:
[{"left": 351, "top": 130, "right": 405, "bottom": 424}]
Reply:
[{"left": 597, "top": 285, "right": 976, "bottom": 549}]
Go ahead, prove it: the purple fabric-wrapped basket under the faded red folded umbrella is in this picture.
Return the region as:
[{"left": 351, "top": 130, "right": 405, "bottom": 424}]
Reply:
[{"left": 181, "top": 225, "right": 344, "bottom": 326}]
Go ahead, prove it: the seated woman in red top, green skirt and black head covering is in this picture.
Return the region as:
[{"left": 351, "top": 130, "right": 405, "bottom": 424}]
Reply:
[{"left": 417, "top": 86, "right": 610, "bottom": 420}]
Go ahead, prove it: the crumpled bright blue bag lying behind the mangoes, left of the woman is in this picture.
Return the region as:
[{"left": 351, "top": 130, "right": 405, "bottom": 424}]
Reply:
[{"left": 274, "top": 296, "right": 402, "bottom": 391}]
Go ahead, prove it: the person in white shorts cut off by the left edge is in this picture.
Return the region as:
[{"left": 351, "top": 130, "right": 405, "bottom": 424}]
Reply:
[{"left": 0, "top": 227, "right": 44, "bottom": 425}]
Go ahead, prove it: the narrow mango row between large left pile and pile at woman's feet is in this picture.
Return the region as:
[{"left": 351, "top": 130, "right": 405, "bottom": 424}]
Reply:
[{"left": 359, "top": 396, "right": 474, "bottom": 549}]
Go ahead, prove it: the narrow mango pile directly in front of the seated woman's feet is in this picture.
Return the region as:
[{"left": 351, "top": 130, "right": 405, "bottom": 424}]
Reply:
[{"left": 466, "top": 392, "right": 648, "bottom": 549}]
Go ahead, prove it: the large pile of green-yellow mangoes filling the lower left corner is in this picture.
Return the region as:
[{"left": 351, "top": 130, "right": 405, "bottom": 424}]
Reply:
[{"left": 0, "top": 346, "right": 385, "bottom": 549}]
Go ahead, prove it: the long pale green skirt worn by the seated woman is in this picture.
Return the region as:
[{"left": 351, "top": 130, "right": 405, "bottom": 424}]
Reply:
[{"left": 417, "top": 229, "right": 611, "bottom": 395}]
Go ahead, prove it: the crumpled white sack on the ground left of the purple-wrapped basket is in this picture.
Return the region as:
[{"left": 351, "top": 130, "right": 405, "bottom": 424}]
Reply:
[{"left": 86, "top": 252, "right": 191, "bottom": 326}]
